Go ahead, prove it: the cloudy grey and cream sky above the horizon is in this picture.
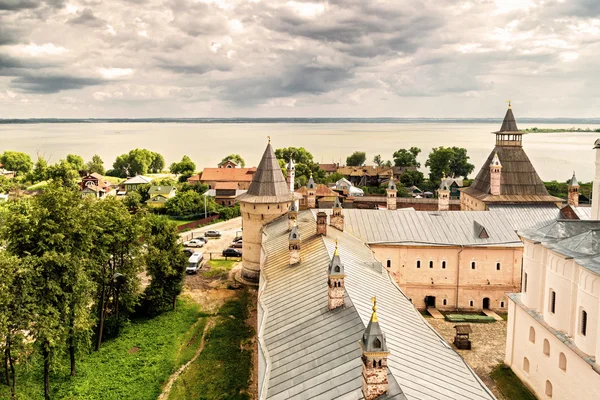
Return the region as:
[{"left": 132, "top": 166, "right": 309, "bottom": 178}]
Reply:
[{"left": 0, "top": 0, "right": 600, "bottom": 118}]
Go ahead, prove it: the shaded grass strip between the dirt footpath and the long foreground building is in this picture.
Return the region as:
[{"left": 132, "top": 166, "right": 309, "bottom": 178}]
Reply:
[{"left": 169, "top": 290, "right": 254, "bottom": 400}]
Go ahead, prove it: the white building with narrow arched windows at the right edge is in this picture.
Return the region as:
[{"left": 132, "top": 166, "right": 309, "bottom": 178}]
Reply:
[{"left": 504, "top": 140, "right": 600, "bottom": 400}]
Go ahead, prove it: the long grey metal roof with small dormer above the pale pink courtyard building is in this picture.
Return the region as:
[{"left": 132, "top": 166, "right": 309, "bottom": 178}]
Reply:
[{"left": 325, "top": 209, "right": 523, "bottom": 247}]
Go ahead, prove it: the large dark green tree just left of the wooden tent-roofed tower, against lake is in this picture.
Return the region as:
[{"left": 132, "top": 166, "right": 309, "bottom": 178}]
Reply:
[{"left": 425, "top": 146, "right": 475, "bottom": 183}]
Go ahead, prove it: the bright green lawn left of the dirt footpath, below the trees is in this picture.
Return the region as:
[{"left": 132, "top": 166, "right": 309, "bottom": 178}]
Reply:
[{"left": 0, "top": 300, "right": 206, "bottom": 400}]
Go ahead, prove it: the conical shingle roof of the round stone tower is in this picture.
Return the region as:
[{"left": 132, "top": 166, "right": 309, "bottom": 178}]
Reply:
[{"left": 239, "top": 142, "right": 292, "bottom": 203}]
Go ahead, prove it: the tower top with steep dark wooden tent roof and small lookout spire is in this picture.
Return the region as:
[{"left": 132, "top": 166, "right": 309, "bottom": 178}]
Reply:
[{"left": 460, "top": 103, "right": 562, "bottom": 210}]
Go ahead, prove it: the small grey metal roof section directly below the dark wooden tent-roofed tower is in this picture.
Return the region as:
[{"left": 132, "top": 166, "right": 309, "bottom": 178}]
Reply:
[{"left": 488, "top": 204, "right": 560, "bottom": 231}]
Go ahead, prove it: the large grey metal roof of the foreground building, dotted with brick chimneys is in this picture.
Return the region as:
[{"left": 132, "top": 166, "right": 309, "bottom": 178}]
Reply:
[{"left": 258, "top": 210, "right": 494, "bottom": 400}]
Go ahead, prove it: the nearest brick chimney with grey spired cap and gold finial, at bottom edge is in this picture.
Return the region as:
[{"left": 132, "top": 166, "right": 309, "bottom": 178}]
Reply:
[{"left": 359, "top": 297, "right": 390, "bottom": 400}]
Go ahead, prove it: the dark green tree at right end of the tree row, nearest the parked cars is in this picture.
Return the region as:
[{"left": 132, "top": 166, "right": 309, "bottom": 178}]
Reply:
[{"left": 144, "top": 215, "right": 186, "bottom": 315}]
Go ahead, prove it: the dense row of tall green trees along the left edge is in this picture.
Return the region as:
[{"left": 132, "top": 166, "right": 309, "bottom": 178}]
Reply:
[{"left": 0, "top": 185, "right": 185, "bottom": 399}]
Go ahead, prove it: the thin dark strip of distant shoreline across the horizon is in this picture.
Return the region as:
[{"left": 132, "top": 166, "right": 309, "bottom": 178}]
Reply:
[{"left": 0, "top": 118, "right": 600, "bottom": 124}]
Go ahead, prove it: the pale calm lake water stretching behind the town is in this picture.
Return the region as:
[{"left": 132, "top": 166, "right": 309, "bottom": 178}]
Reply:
[{"left": 0, "top": 122, "right": 600, "bottom": 181}]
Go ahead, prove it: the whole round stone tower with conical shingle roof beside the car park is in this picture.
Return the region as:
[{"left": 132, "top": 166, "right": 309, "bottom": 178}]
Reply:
[{"left": 238, "top": 139, "right": 293, "bottom": 284}]
